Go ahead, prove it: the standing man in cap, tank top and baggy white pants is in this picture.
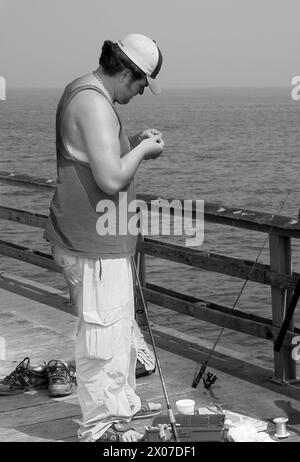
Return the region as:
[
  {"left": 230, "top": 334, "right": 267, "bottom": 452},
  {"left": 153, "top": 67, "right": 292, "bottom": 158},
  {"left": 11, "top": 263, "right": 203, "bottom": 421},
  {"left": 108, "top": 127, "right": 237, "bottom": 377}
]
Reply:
[{"left": 45, "top": 34, "right": 164, "bottom": 442}]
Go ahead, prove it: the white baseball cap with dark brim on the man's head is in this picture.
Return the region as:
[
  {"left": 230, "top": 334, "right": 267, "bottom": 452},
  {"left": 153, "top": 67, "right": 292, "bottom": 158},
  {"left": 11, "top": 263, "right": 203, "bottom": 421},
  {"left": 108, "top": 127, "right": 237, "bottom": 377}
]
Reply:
[{"left": 118, "top": 34, "right": 163, "bottom": 95}]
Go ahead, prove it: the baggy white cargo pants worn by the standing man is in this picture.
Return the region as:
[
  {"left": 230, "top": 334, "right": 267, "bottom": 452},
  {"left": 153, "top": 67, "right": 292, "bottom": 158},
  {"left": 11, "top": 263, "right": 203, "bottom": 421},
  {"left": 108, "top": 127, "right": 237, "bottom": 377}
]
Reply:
[{"left": 52, "top": 247, "right": 141, "bottom": 442}]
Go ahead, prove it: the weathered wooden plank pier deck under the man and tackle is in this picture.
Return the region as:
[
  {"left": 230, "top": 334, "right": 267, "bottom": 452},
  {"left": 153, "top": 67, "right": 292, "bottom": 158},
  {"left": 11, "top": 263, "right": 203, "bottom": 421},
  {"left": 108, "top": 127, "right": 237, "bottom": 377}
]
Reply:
[{"left": 0, "top": 272, "right": 300, "bottom": 442}]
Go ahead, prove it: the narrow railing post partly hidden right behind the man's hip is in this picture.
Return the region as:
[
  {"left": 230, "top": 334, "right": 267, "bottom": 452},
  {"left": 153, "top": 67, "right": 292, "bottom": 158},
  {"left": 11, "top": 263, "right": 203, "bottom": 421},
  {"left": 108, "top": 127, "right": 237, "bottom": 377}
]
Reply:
[{"left": 135, "top": 235, "right": 147, "bottom": 331}]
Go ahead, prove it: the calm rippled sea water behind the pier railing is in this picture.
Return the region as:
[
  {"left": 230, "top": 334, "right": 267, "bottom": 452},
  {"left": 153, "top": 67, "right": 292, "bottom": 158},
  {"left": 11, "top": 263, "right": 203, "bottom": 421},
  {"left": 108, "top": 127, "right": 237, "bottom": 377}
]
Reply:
[{"left": 0, "top": 89, "right": 300, "bottom": 340}]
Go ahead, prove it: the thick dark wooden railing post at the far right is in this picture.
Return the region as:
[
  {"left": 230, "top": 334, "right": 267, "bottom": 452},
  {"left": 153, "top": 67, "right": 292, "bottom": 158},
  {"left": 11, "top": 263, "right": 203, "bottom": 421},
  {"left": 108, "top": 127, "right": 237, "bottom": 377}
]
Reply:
[{"left": 269, "top": 234, "right": 296, "bottom": 383}]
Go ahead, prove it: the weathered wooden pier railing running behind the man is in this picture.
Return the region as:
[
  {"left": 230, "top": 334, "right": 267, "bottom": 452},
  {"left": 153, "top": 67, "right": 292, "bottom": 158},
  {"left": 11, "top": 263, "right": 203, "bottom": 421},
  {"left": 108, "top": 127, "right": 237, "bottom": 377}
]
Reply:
[{"left": 0, "top": 172, "right": 300, "bottom": 383}]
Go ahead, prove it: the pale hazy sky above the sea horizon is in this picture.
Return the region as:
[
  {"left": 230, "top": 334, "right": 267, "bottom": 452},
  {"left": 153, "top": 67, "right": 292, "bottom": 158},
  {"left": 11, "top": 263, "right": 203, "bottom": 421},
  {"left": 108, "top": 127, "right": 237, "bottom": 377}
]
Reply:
[{"left": 0, "top": 0, "right": 300, "bottom": 87}]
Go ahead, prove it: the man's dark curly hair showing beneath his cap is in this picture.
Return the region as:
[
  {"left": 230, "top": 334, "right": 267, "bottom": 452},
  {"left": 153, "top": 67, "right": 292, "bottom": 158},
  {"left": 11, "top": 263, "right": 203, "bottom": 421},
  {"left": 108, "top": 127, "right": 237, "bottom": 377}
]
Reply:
[{"left": 99, "top": 40, "right": 145, "bottom": 80}]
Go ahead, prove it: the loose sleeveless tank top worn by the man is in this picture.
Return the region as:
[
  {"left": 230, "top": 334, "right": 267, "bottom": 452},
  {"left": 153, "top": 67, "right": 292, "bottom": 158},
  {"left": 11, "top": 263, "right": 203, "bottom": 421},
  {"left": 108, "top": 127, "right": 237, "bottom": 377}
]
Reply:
[{"left": 44, "top": 81, "right": 137, "bottom": 258}]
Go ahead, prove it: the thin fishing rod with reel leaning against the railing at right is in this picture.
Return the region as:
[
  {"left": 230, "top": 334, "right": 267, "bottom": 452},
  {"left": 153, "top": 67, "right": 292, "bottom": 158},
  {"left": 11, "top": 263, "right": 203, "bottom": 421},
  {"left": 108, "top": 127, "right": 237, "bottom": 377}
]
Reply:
[{"left": 192, "top": 171, "right": 300, "bottom": 388}]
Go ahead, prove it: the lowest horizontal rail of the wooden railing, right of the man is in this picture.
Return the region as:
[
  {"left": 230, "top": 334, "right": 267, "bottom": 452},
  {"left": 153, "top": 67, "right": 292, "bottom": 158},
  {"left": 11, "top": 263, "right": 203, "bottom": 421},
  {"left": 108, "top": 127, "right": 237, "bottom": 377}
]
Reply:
[{"left": 143, "top": 284, "right": 300, "bottom": 344}]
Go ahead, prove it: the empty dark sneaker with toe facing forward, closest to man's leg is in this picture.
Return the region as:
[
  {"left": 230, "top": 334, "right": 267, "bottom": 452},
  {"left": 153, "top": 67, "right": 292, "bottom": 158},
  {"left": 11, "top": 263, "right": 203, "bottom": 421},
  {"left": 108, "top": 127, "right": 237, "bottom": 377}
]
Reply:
[{"left": 47, "top": 359, "right": 76, "bottom": 397}]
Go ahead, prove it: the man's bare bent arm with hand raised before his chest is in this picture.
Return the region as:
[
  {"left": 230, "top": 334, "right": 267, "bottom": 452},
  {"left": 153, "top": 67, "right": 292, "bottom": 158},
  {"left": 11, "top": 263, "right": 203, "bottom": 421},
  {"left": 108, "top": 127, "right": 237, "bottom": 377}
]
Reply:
[{"left": 76, "top": 92, "right": 163, "bottom": 194}]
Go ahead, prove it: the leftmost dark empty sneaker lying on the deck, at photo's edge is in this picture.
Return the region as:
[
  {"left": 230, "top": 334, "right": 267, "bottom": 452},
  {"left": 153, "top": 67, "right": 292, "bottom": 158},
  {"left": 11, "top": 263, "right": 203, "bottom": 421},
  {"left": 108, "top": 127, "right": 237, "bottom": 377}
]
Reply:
[{"left": 0, "top": 357, "right": 48, "bottom": 395}]
